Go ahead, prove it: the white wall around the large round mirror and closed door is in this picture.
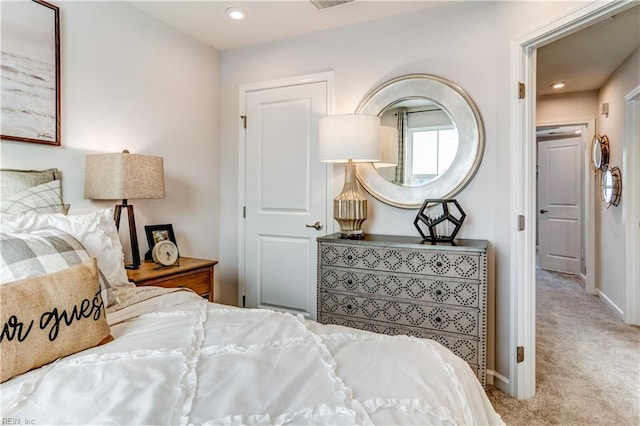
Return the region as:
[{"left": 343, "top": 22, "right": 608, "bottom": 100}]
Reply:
[{"left": 219, "top": 2, "right": 580, "bottom": 387}]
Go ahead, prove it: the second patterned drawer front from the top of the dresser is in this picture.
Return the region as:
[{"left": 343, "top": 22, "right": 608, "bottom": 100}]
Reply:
[{"left": 320, "top": 267, "right": 479, "bottom": 308}]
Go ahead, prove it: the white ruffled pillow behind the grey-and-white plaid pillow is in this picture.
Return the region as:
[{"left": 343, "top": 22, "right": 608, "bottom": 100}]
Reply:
[{"left": 0, "top": 208, "right": 135, "bottom": 296}]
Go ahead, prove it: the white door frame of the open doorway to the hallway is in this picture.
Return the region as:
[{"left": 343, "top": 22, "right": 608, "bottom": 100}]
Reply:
[{"left": 509, "top": 2, "right": 640, "bottom": 399}]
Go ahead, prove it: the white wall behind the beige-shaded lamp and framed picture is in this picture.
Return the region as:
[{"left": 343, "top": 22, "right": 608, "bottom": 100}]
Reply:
[{"left": 1, "top": 2, "right": 220, "bottom": 300}]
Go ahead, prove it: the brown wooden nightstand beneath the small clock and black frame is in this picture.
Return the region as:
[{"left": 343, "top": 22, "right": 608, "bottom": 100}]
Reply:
[{"left": 127, "top": 257, "right": 218, "bottom": 302}]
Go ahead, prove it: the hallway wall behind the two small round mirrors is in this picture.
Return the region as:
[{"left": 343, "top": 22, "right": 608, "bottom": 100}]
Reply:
[{"left": 596, "top": 49, "right": 640, "bottom": 316}]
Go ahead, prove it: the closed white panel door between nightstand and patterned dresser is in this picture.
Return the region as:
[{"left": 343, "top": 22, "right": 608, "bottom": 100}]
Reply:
[{"left": 244, "top": 81, "right": 328, "bottom": 319}]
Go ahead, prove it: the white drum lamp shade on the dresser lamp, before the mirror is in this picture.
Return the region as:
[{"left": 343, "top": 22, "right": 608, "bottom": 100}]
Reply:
[{"left": 318, "top": 114, "right": 380, "bottom": 163}]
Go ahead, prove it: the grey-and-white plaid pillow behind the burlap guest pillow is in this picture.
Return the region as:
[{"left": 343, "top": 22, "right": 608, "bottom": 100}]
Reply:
[{"left": 0, "top": 229, "right": 115, "bottom": 306}]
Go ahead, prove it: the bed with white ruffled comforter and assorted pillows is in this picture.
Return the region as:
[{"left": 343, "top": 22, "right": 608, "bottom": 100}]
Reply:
[{"left": 0, "top": 168, "right": 503, "bottom": 425}]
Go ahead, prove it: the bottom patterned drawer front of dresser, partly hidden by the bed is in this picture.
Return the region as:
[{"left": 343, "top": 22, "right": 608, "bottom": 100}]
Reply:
[{"left": 319, "top": 313, "right": 478, "bottom": 362}]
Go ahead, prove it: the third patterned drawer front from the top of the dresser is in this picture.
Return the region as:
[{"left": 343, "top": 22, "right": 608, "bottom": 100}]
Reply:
[{"left": 318, "top": 291, "right": 478, "bottom": 336}]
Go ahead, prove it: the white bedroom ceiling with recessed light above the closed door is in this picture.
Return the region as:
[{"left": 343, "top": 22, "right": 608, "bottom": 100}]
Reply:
[{"left": 130, "top": 0, "right": 450, "bottom": 51}]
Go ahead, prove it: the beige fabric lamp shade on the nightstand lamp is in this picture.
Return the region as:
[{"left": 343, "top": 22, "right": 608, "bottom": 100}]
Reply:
[{"left": 84, "top": 151, "right": 165, "bottom": 200}]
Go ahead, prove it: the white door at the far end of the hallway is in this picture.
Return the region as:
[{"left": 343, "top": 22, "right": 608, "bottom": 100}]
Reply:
[{"left": 538, "top": 137, "right": 582, "bottom": 274}]
